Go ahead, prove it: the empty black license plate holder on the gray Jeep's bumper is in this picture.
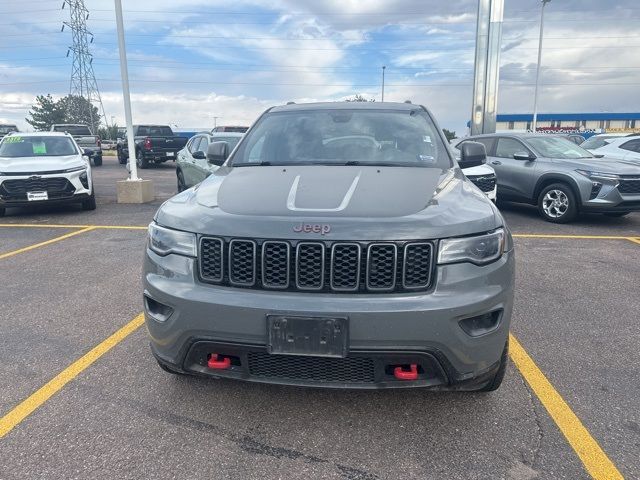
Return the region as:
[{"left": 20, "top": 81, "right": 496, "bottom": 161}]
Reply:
[{"left": 267, "top": 315, "right": 349, "bottom": 358}]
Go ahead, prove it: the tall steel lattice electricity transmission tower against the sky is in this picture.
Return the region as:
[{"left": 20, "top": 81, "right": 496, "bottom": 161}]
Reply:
[{"left": 62, "top": 0, "right": 107, "bottom": 134}]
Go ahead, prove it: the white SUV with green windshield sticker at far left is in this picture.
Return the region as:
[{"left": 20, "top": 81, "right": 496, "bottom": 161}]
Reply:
[{"left": 0, "top": 132, "right": 96, "bottom": 217}]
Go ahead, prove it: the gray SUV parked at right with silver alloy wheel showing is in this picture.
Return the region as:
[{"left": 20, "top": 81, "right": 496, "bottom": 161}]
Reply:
[{"left": 463, "top": 134, "right": 640, "bottom": 223}]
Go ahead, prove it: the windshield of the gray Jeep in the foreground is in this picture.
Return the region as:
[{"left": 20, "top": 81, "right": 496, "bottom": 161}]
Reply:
[{"left": 231, "top": 108, "right": 451, "bottom": 169}]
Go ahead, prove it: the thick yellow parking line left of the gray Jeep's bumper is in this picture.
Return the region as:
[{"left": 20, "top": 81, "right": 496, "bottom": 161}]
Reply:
[{"left": 0, "top": 313, "right": 144, "bottom": 439}]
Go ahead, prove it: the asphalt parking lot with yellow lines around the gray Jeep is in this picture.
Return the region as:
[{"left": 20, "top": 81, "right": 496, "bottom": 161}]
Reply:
[{"left": 0, "top": 157, "right": 640, "bottom": 480}]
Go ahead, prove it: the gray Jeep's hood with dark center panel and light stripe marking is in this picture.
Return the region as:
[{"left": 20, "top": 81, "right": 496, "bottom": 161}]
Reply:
[{"left": 156, "top": 166, "right": 503, "bottom": 240}]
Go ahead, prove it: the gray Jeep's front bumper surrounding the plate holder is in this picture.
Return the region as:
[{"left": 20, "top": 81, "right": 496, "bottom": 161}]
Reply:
[{"left": 144, "top": 250, "right": 515, "bottom": 389}]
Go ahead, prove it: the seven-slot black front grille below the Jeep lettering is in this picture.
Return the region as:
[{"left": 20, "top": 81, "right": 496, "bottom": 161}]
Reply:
[{"left": 198, "top": 237, "right": 434, "bottom": 293}]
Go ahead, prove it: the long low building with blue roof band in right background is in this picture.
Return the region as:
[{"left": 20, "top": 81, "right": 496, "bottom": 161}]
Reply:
[{"left": 496, "top": 113, "right": 640, "bottom": 136}]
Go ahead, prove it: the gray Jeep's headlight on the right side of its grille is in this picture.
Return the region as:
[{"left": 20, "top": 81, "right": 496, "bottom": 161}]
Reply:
[{"left": 438, "top": 228, "right": 512, "bottom": 265}]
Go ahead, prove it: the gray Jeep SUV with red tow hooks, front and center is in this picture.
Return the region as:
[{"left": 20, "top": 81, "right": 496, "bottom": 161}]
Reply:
[{"left": 143, "top": 103, "right": 515, "bottom": 391}]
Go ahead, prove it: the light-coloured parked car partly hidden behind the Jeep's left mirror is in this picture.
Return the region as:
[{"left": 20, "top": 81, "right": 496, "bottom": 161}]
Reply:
[{"left": 176, "top": 132, "right": 243, "bottom": 192}]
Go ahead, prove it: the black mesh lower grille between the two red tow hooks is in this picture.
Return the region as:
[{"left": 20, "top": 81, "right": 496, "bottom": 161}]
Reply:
[{"left": 248, "top": 352, "right": 375, "bottom": 383}]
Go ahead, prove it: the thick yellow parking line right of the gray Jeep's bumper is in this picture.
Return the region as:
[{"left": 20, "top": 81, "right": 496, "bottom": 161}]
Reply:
[{"left": 509, "top": 335, "right": 624, "bottom": 480}]
